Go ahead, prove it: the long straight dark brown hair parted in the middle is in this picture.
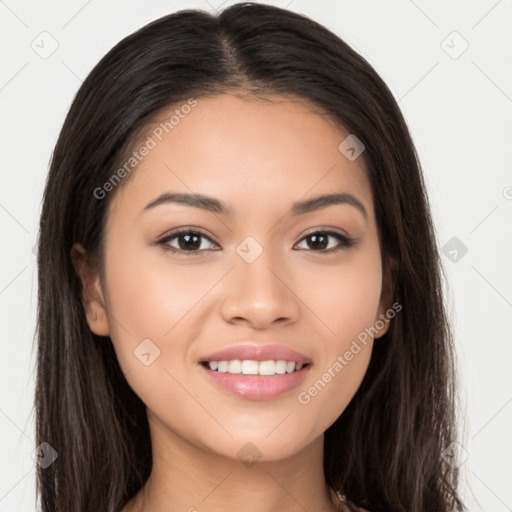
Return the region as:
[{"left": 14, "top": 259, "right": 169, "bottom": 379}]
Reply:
[{"left": 35, "top": 3, "right": 464, "bottom": 512}]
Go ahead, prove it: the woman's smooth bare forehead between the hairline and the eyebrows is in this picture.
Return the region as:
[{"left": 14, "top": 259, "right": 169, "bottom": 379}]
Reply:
[{"left": 109, "top": 94, "right": 373, "bottom": 224}]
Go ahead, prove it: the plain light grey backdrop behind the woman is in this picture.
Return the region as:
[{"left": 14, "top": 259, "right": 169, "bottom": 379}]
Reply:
[{"left": 0, "top": 0, "right": 512, "bottom": 512}]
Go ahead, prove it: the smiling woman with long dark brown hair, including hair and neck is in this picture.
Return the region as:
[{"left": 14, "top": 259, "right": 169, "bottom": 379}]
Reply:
[{"left": 36, "top": 3, "right": 463, "bottom": 512}]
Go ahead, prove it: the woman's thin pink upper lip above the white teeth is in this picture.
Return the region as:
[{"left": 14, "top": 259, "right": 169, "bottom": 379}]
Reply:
[{"left": 200, "top": 344, "right": 312, "bottom": 365}]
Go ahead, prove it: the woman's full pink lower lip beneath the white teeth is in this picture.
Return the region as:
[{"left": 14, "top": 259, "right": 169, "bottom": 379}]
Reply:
[{"left": 199, "top": 364, "right": 311, "bottom": 400}]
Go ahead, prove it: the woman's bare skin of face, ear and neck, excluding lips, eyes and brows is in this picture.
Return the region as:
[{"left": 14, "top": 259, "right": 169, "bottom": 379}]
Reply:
[{"left": 72, "top": 94, "right": 390, "bottom": 512}]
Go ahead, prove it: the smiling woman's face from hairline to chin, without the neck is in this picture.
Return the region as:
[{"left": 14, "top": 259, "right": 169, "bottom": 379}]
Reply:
[{"left": 76, "top": 95, "right": 388, "bottom": 460}]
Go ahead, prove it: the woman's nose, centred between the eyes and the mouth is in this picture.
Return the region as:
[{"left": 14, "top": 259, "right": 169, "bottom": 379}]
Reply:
[{"left": 222, "top": 247, "right": 300, "bottom": 329}]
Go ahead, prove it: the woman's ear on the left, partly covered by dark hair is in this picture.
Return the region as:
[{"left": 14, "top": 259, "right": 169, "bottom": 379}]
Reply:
[{"left": 70, "top": 243, "right": 110, "bottom": 336}]
